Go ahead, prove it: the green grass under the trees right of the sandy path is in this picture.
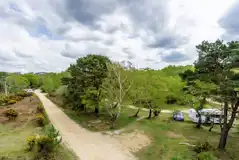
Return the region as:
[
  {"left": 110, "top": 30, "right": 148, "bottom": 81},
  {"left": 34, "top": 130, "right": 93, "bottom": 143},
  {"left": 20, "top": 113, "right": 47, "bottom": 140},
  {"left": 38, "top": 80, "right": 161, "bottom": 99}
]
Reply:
[{"left": 47, "top": 95, "right": 239, "bottom": 160}]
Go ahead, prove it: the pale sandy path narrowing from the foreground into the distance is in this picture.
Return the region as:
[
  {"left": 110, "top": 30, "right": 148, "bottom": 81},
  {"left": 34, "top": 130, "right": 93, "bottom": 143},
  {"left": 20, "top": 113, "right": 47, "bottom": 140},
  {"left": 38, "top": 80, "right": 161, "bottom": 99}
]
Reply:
[{"left": 35, "top": 90, "right": 136, "bottom": 160}]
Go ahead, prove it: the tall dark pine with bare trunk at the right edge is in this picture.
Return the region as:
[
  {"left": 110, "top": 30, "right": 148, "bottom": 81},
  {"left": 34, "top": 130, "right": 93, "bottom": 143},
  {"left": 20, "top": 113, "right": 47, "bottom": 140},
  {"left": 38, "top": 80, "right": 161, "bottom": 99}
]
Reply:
[{"left": 195, "top": 40, "right": 239, "bottom": 150}]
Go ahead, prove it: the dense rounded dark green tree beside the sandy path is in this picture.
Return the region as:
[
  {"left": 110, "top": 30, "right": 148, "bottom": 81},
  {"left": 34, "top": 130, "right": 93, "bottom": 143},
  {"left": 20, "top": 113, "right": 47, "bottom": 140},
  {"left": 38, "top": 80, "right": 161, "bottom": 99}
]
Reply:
[{"left": 62, "top": 54, "right": 111, "bottom": 114}]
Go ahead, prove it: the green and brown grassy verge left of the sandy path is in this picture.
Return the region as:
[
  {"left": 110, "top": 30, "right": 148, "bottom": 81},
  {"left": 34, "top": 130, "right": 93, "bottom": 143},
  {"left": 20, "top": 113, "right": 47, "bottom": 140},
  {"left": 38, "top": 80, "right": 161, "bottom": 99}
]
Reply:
[{"left": 0, "top": 97, "right": 76, "bottom": 160}]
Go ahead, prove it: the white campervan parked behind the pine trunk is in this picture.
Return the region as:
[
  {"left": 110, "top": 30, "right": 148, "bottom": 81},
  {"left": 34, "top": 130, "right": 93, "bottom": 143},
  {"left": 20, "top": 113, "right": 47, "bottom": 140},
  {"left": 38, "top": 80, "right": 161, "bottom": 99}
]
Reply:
[{"left": 188, "top": 109, "right": 223, "bottom": 124}]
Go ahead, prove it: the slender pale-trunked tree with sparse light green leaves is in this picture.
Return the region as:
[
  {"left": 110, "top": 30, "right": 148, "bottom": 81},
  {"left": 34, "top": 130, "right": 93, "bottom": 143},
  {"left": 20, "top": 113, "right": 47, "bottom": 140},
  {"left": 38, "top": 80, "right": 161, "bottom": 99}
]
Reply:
[{"left": 102, "top": 63, "right": 133, "bottom": 128}]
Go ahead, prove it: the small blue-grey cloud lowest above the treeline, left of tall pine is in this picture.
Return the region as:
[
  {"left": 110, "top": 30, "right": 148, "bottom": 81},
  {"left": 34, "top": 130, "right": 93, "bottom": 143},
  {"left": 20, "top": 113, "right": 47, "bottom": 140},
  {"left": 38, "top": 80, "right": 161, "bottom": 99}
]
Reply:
[{"left": 161, "top": 51, "right": 189, "bottom": 63}]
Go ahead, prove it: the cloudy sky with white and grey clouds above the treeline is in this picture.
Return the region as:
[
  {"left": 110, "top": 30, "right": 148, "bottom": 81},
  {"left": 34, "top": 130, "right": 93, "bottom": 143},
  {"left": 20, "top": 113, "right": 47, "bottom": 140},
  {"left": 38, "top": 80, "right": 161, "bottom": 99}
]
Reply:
[{"left": 0, "top": 0, "right": 239, "bottom": 72}]
